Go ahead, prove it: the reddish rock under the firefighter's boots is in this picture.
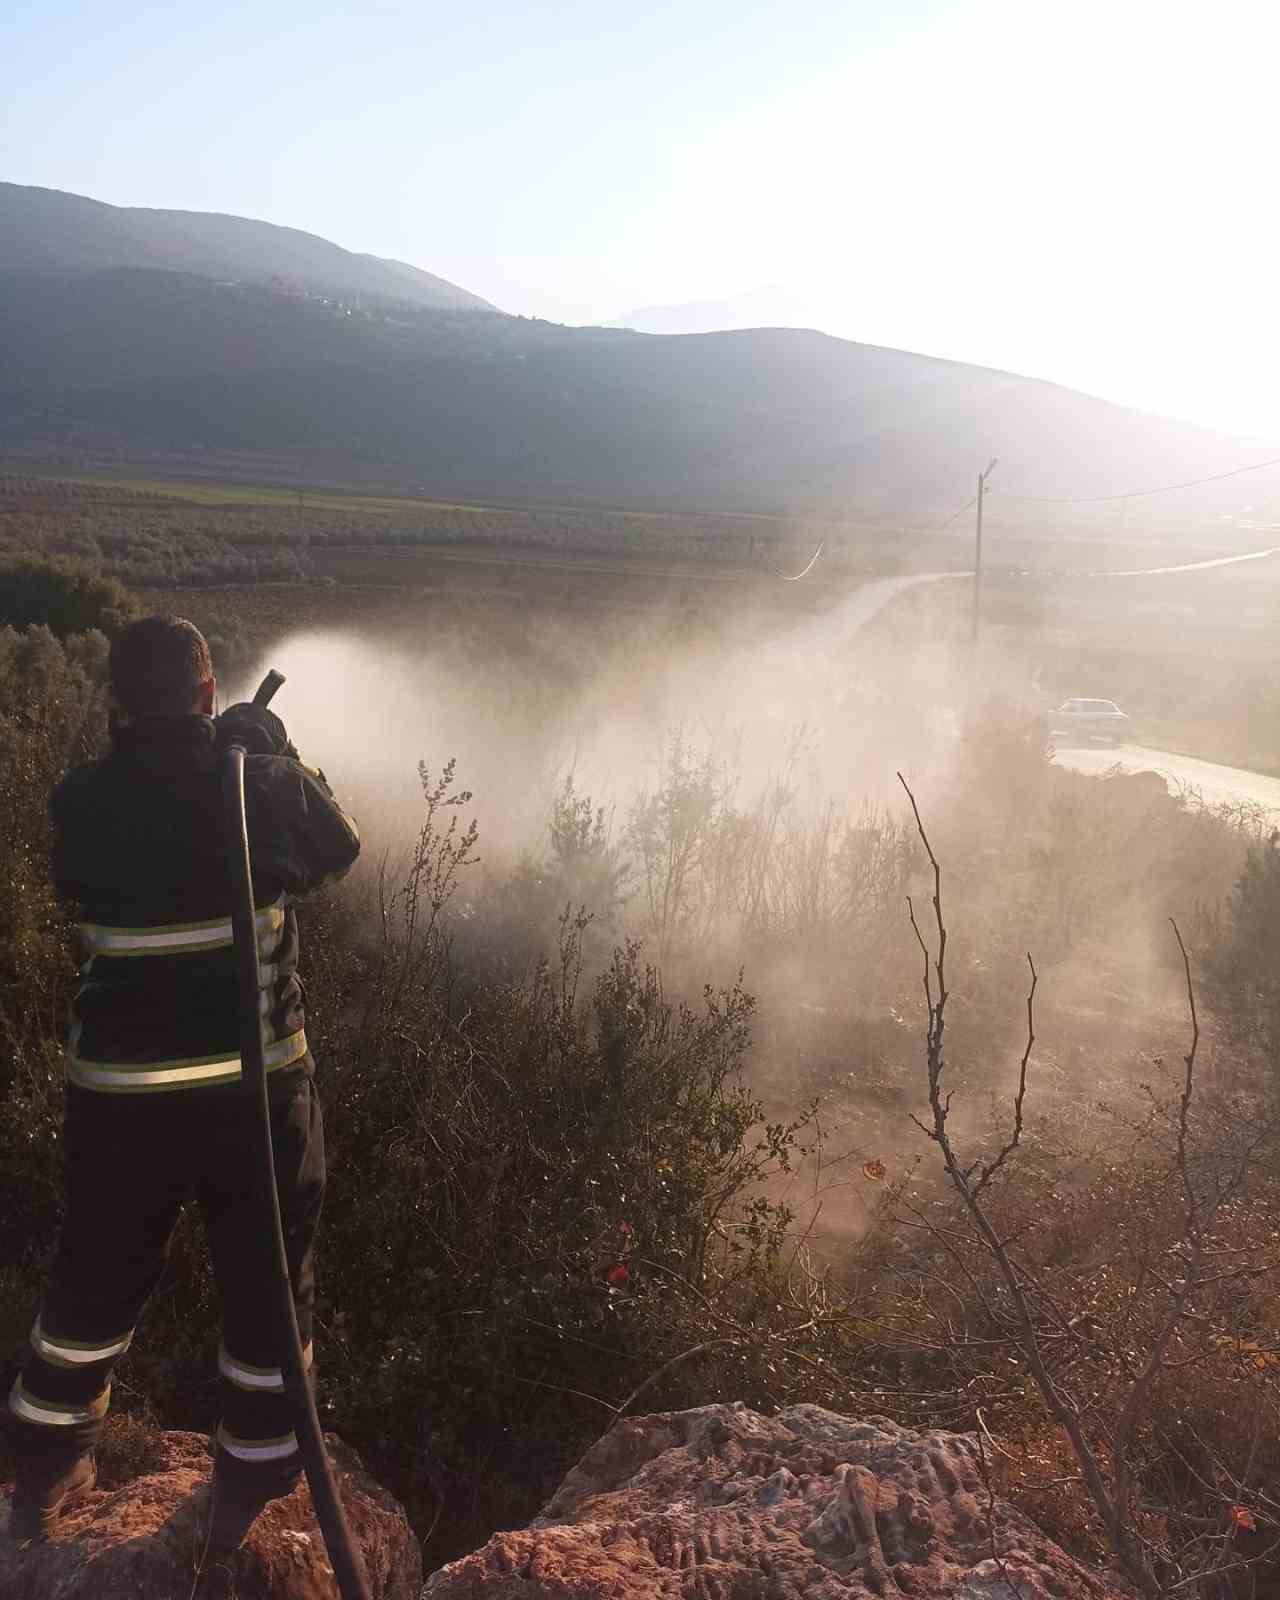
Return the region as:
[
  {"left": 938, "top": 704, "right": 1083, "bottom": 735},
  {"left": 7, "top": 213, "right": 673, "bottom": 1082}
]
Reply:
[{"left": 0, "top": 1434, "right": 422, "bottom": 1600}]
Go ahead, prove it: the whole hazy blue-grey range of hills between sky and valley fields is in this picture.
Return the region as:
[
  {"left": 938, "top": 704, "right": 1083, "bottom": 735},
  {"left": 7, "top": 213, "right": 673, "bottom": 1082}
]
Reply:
[{"left": 0, "top": 186, "right": 1280, "bottom": 524}]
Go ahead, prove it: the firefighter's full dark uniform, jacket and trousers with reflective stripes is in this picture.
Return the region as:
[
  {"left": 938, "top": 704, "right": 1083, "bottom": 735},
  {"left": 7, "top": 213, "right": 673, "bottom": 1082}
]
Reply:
[{"left": 10, "top": 710, "right": 360, "bottom": 1482}]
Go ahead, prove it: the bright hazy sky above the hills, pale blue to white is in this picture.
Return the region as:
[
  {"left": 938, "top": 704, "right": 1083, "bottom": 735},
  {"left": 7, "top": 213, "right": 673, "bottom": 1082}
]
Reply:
[{"left": 10, "top": 0, "right": 1280, "bottom": 438}]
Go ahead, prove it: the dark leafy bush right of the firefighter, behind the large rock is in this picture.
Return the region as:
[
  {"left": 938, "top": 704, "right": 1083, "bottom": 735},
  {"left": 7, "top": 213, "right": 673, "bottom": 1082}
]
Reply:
[{"left": 294, "top": 768, "right": 800, "bottom": 1542}]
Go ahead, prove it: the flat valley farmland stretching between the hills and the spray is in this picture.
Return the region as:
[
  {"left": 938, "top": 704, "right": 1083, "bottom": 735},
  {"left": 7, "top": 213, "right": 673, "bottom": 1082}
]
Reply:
[{"left": 10, "top": 470, "right": 1280, "bottom": 773}]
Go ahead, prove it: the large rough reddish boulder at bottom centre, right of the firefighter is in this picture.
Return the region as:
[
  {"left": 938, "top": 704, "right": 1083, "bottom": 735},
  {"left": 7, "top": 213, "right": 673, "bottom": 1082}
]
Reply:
[{"left": 422, "top": 1405, "right": 1120, "bottom": 1600}]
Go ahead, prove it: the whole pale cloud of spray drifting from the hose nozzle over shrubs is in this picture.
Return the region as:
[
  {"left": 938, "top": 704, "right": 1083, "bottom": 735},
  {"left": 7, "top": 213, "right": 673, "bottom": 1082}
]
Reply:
[{"left": 232, "top": 576, "right": 1243, "bottom": 1237}]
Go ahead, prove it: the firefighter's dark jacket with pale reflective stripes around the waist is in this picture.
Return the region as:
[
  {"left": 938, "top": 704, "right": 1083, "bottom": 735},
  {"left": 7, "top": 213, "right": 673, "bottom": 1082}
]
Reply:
[{"left": 51, "top": 717, "right": 360, "bottom": 1094}]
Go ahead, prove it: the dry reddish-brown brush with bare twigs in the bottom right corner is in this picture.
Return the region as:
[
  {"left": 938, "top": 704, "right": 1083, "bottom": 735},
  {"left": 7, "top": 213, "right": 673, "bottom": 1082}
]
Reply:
[{"left": 838, "top": 784, "right": 1280, "bottom": 1597}]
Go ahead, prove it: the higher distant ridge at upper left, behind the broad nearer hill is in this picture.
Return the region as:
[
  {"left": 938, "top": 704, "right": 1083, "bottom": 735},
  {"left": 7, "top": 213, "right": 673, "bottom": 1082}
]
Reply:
[{"left": 0, "top": 182, "right": 493, "bottom": 310}]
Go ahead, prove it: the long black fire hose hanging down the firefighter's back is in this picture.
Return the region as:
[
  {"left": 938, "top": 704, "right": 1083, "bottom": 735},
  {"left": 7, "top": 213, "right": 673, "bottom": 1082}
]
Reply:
[{"left": 222, "top": 670, "right": 371, "bottom": 1600}]
